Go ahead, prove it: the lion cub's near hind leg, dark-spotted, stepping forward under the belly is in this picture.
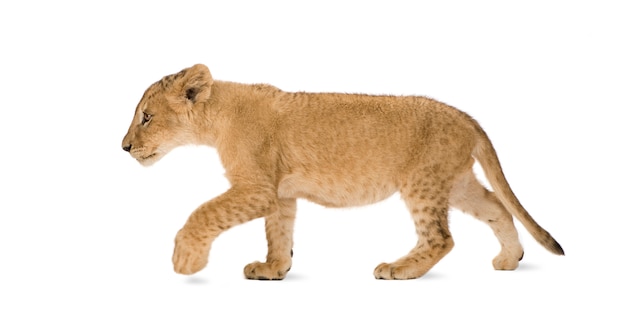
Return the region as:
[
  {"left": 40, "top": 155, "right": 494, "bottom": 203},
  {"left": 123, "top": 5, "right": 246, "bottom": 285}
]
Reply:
[{"left": 374, "top": 176, "right": 454, "bottom": 280}]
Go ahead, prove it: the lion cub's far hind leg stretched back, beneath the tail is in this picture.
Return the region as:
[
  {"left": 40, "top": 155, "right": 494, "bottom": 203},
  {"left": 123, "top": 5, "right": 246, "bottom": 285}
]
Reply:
[{"left": 450, "top": 170, "right": 524, "bottom": 270}]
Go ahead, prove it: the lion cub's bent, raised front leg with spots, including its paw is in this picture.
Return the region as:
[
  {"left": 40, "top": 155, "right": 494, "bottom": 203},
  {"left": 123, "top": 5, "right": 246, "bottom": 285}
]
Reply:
[{"left": 172, "top": 187, "right": 275, "bottom": 275}]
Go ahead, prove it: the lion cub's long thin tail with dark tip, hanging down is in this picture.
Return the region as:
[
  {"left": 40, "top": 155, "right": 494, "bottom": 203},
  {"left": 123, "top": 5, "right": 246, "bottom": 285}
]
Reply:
[{"left": 472, "top": 123, "right": 565, "bottom": 255}]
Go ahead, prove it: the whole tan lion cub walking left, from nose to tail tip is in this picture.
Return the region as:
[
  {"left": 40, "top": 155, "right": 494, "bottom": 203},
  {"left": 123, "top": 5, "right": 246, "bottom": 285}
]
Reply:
[{"left": 122, "top": 65, "right": 563, "bottom": 279}]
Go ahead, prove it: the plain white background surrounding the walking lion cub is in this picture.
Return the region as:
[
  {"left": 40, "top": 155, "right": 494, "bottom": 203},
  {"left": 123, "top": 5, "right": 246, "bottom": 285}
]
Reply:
[{"left": 0, "top": 1, "right": 626, "bottom": 314}]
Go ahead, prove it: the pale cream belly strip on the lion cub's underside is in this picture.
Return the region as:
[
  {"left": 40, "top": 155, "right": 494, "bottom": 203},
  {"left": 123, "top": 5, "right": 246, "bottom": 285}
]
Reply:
[{"left": 278, "top": 174, "right": 396, "bottom": 207}]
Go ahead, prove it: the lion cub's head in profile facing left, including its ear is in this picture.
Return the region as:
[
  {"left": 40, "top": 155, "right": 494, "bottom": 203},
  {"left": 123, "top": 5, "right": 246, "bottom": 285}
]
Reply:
[{"left": 122, "top": 65, "right": 213, "bottom": 166}]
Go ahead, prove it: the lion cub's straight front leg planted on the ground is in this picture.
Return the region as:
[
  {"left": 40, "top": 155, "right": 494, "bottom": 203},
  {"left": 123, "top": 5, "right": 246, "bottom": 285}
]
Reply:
[{"left": 243, "top": 199, "right": 296, "bottom": 280}]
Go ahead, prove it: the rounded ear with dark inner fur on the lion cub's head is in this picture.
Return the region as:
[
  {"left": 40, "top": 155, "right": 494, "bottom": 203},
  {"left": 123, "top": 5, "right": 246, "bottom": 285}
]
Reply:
[{"left": 170, "top": 64, "right": 213, "bottom": 110}]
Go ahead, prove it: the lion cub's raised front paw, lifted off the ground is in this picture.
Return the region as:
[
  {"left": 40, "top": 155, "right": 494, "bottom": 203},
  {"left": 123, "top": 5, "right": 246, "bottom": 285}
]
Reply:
[{"left": 172, "top": 229, "right": 211, "bottom": 275}]
